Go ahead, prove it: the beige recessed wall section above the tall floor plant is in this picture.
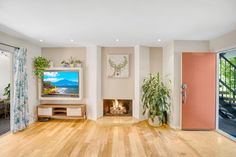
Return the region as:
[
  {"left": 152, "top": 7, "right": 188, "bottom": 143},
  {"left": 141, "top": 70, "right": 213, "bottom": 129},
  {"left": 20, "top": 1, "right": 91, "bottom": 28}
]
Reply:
[{"left": 149, "top": 47, "right": 163, "bottom": 75}]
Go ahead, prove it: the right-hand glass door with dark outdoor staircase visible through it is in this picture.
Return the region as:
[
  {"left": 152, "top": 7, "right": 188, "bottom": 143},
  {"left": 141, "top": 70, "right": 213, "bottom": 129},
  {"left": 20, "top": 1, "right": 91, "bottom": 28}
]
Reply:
[{"left": 217, "top": 49, "right": 236, "bottom": 139}]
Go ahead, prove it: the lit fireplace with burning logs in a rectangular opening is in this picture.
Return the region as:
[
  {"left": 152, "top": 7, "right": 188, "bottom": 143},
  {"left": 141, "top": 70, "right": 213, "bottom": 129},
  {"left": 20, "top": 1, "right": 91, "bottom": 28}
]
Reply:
[{"left": 103, "top": 99, "right": 132, "bottom": 116}]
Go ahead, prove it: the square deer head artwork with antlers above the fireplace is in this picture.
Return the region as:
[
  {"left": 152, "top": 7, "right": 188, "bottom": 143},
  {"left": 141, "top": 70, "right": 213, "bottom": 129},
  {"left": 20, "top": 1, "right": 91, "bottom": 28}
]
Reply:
[{"left": 107, "top": 54, "right": 129, "bottom": 78}]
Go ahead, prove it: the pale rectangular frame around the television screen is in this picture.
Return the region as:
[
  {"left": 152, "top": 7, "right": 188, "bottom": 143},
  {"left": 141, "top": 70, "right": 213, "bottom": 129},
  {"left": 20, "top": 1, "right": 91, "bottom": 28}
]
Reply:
[{"left": 38, "top": 67, "right": 83, "bottom": 101}]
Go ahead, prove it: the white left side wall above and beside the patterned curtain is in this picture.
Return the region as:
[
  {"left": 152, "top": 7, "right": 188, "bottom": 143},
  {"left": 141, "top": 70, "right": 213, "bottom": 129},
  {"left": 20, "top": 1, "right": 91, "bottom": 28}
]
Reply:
[{"left": 0, "top": 32, "right": 41, "bottom": 123}]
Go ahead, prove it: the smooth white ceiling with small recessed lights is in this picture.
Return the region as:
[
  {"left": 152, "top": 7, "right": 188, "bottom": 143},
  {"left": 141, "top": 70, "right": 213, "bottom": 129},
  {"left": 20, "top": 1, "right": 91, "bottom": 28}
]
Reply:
[{"left": 0, "top": 0, "right": 236, "bottom": 47}]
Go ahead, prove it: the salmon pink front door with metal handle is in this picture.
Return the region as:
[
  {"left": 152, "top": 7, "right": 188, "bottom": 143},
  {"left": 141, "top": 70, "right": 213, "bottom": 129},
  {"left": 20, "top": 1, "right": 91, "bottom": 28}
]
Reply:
[{"left": 182, "top": 53, "right": 216, "bottom": 130}]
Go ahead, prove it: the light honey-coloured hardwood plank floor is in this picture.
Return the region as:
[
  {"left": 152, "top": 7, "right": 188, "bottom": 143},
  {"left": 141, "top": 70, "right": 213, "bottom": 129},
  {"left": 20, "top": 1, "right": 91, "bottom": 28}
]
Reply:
[{"left": 0, "top": 120, "right": 236, "bottom": 157}]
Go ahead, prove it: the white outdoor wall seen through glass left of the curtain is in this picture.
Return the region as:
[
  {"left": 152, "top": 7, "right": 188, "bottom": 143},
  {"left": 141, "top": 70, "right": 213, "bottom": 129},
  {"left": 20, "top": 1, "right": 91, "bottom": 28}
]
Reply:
[{"left": 0, "top": 53, "right": 11, "bottom": 99}]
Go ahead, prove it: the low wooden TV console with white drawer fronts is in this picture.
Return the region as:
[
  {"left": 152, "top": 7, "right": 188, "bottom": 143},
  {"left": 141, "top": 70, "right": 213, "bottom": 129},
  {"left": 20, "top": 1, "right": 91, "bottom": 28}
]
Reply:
[{"left": 37, "top": 104, "right": 86, "bottom": 119}]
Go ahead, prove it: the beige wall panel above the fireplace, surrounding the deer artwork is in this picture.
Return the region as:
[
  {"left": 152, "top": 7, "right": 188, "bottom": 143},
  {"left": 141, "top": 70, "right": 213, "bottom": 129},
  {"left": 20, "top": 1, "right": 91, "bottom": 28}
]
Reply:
[{"left": 101, "top": 47, "right": 134, "bottom": 99}]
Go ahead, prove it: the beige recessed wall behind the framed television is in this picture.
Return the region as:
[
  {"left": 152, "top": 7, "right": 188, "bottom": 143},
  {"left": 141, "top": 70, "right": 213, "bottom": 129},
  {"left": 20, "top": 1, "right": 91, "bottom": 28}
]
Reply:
[{"left": 42, "top": 47, "right": 86, "bottom": 104}]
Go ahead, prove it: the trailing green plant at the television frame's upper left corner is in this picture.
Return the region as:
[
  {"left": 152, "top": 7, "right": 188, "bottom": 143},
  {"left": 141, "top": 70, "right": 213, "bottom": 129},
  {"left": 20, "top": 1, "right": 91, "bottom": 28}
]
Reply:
[{"left": 33, "top": 57, "right": 50, "bottom": 78}]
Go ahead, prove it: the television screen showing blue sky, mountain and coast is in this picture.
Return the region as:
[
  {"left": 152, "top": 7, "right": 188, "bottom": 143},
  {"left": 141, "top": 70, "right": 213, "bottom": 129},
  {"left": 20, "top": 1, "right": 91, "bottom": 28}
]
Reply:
[{"left": 42, "top": 71, "right": 79, "bottom": 97}]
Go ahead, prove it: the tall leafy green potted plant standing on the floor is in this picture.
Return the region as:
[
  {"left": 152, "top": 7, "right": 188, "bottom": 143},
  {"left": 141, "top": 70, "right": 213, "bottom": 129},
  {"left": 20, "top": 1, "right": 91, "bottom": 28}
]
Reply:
[{"left": 142, "top": 73, "right": 171, "bottom": 126}]
